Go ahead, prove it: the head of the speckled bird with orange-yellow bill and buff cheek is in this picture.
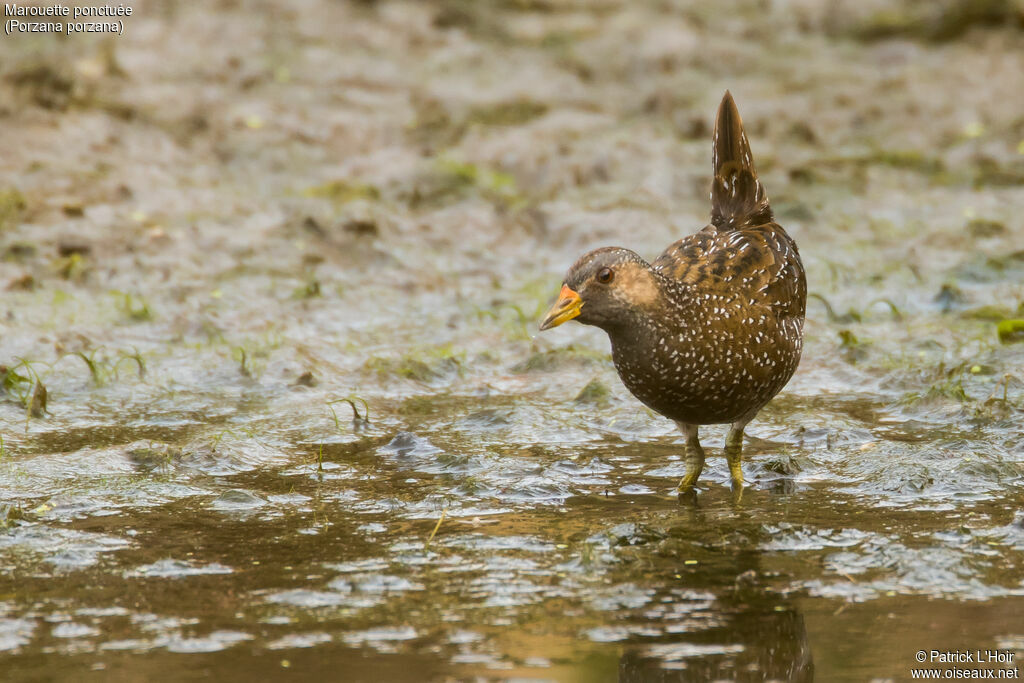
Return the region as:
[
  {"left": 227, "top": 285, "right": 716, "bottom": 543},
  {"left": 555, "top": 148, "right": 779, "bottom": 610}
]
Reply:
[{"left": 541, "top": 247, "right": 659, "bottom": 331}]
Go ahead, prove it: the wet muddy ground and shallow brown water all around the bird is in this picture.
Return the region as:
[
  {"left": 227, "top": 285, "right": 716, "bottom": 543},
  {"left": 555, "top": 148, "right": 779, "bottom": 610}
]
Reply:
[{"left": 0, "top": 2, "right": 1024, "bottom": 681}]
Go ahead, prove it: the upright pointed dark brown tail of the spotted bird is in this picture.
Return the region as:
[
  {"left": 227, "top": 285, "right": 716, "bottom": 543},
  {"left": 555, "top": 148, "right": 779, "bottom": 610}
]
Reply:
[{"left": 711, "top": 90, "right": 772, "bottom": 230}]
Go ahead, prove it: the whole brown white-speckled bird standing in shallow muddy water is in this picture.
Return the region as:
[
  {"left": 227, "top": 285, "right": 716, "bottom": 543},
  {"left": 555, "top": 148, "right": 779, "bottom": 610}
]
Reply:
[{"left": 541, "top": 92, "right": 807, "bottom": 489}]
